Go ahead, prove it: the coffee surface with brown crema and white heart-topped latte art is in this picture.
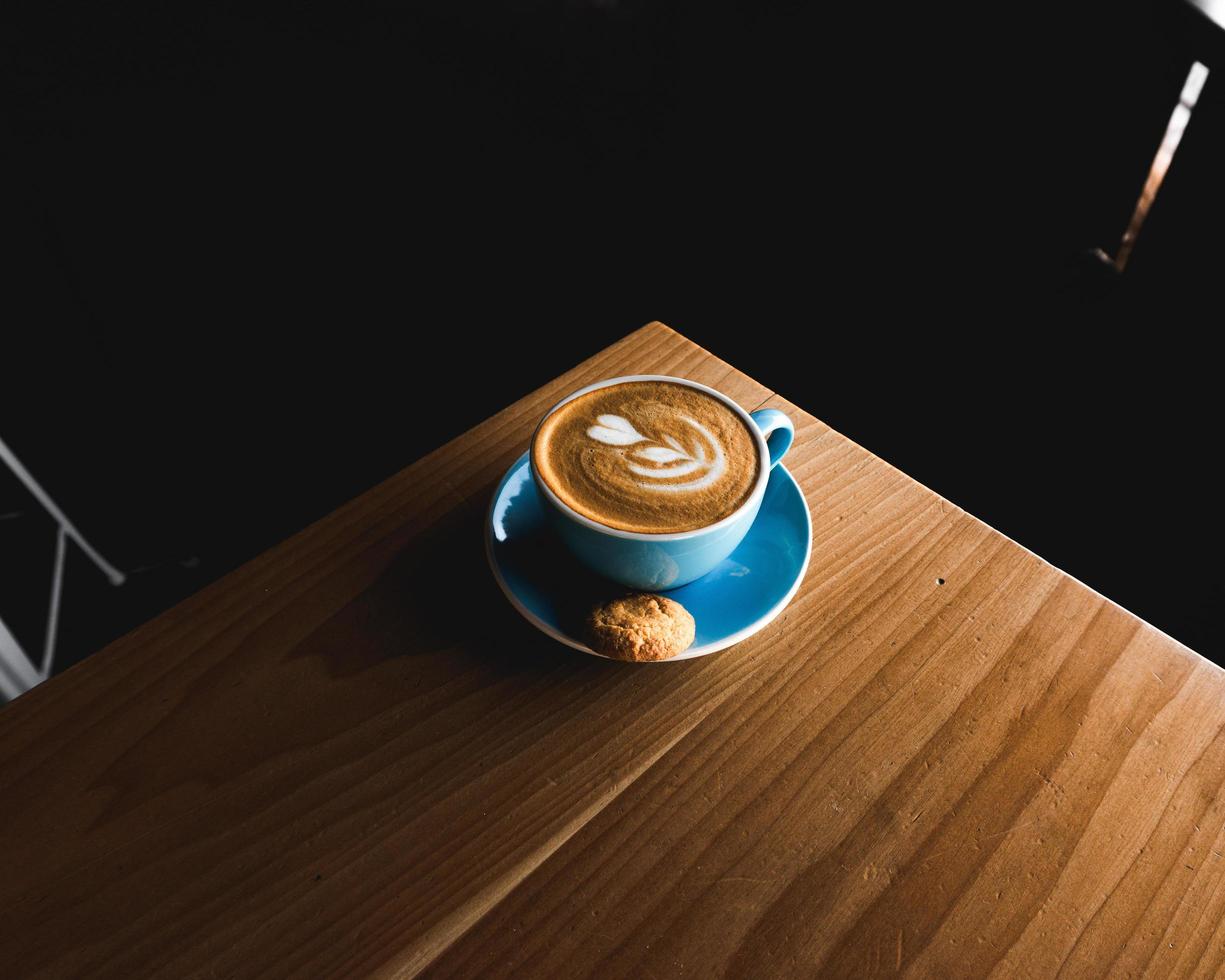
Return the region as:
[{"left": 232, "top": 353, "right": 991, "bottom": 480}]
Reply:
[{"left": 532, "top": 381, "right": 761, "bottom": 534}]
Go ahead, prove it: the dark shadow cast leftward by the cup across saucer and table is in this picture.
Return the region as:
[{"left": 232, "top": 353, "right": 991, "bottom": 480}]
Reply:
[{"left": 293, "top": 472, "right": 707, "bottom": 701}]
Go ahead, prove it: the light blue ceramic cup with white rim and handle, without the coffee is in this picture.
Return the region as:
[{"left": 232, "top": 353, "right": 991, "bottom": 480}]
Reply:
[{"left": 528, "top": 375, "right": 795, "bottom": 592}]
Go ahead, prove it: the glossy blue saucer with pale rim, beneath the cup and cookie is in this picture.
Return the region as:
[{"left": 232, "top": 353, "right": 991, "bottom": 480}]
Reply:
[{"left": 485, "top": 453, "right": 812, "bottom": 660}]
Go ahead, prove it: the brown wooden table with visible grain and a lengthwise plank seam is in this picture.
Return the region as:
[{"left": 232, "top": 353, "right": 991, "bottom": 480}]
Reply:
[{"left": 0, "top": 323, "right": 1225, "bottom": 980}]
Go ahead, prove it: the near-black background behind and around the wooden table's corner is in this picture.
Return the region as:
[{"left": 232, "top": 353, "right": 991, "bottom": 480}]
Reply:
[{"left": 0, "top": 0, "right": 1225, "bottom": 681}]
